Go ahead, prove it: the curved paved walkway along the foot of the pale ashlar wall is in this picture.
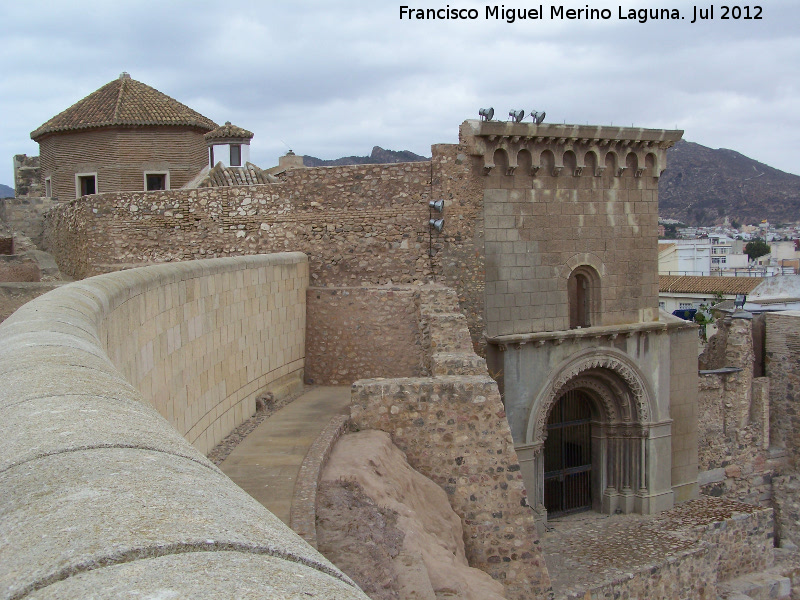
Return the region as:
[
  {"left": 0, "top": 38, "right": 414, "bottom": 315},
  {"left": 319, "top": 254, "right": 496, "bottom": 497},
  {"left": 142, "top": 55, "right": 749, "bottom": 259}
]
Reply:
[{"left": 219, "top": 386, "right": 350, "bottom": 525}]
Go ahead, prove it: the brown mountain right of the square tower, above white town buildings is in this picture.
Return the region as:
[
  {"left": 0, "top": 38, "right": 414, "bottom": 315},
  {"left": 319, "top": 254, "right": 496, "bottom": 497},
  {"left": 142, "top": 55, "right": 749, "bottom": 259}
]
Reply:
[{"left": 658, "top": 140, "right": 800, "bottom": 225}]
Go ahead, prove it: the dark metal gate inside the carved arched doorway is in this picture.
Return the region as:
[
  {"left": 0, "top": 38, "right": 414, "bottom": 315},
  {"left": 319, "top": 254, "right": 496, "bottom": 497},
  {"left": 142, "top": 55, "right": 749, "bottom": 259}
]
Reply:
[{"left": 543, "top": 390, "right": 592, "bottom": 516}]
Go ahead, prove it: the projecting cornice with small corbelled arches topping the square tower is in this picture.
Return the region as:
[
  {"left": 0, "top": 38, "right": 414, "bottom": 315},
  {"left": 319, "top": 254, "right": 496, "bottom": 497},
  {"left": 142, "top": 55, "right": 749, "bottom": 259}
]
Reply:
[{"left": 459, "top": 120, "right": 683, "bottom": 178}]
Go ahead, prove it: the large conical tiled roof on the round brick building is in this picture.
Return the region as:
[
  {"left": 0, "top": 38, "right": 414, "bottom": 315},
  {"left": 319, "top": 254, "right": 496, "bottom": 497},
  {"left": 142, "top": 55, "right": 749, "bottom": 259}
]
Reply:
[{"left": 31, "top": 73, "right": 217, "bottom": 141}]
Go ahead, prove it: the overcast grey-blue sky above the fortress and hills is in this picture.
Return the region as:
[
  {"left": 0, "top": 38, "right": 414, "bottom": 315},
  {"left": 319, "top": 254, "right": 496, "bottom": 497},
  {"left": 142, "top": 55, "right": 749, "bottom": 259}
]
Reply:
[{"left": 0, "top": 0, "right": 800, "bottom": 187}]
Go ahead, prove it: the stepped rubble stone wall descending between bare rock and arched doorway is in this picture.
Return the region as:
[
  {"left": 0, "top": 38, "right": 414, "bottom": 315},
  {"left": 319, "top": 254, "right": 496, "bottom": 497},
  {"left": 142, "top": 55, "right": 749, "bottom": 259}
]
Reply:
[{"left": 351, "top": 287, "right": 552, "bottom": 599}]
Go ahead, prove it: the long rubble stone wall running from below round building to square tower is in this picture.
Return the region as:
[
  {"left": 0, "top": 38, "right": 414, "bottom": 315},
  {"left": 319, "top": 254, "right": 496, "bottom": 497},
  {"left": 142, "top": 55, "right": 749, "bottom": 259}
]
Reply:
[{"left": 44, "top": 144, "right": 483, "bottom": 344}]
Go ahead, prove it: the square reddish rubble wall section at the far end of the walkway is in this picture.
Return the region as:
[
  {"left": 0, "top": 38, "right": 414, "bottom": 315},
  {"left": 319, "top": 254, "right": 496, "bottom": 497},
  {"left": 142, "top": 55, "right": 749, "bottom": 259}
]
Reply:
[{"left": 305, "top": 286, "right": 425, "bottom": 385}]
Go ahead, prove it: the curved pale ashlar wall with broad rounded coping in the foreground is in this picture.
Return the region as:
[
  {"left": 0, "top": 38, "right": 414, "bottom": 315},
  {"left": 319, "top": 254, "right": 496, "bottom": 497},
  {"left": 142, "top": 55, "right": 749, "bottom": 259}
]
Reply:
[{"left": 0, "top": 253, "right": 366, "bottom": 600}]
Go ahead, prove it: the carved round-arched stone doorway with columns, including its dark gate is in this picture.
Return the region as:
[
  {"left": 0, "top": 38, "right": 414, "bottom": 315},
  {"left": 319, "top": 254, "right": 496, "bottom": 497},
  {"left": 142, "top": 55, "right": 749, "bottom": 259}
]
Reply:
[{"left": 524, "top": 349, "right": 669, "bottom": 518}]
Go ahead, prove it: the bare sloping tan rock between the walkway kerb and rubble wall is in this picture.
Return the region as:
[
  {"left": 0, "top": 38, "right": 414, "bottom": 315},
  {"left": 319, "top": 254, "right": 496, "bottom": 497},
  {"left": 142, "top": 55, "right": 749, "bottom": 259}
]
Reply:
[{"left": 317, "top": 431, "right": 504, "bottom": 600}]
